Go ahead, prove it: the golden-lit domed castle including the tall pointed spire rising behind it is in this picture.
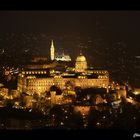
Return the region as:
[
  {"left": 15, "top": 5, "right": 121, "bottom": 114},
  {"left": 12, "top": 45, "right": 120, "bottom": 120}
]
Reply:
[{"left": 17, "top": 41, "right": 109, "bottom": 94}]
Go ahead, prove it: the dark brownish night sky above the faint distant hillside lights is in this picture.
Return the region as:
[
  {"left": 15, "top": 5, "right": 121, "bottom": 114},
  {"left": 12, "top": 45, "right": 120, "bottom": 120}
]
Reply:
[{"left": 0, "top": 11, "right": 140, "bottom": 33}]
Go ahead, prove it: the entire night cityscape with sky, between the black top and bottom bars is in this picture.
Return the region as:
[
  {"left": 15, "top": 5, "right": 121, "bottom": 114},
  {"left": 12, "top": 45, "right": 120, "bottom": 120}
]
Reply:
[{"left": 0, "top": 10, "right": 140, "bottom": 130}]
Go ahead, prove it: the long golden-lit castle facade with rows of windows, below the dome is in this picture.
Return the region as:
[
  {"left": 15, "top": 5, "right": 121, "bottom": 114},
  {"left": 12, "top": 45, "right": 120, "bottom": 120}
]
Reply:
[{"left": 18, "top": 70, "right": 109, "bottom": 94}]
